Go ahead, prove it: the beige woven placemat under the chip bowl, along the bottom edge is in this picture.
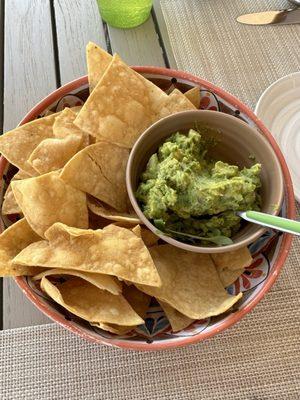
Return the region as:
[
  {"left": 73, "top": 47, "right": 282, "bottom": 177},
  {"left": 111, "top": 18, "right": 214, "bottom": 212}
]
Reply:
[{"left": 0, "top": 233, "right": 300, "bottom": 400}]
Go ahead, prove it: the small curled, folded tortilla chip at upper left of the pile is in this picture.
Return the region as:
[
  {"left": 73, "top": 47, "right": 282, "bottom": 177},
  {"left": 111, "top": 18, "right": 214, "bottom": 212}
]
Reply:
[{"left": 28, "top": 108, "right": 89, "bottom": 174}]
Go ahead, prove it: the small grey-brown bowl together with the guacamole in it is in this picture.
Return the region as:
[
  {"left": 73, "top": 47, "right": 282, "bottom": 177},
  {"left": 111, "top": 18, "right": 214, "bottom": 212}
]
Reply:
[{"left": 127, "top": 111, "right": 283, "bottom": 253}]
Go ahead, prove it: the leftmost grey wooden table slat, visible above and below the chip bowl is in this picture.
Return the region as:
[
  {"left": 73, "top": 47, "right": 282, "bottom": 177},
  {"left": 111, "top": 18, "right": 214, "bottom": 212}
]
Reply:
[{"left": 3, "top": 0, "right": 56, "bottom": 329}]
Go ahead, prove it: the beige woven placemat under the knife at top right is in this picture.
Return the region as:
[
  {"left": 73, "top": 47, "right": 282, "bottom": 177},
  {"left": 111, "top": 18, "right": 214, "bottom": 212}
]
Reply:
[{"left": 161, "top": 0, "right": 300, "bottom": 108}]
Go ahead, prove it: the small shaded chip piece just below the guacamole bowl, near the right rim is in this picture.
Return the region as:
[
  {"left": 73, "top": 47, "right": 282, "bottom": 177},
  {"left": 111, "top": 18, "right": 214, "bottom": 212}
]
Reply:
[{"left": 211, "top": 247, "right": 253, "bottom": 271}]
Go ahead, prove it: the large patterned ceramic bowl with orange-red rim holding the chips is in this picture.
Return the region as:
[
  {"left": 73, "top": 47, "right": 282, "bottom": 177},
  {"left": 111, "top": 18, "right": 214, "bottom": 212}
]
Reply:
[{"left": 0, "top": 67, "right": 295, "bottom": 350}]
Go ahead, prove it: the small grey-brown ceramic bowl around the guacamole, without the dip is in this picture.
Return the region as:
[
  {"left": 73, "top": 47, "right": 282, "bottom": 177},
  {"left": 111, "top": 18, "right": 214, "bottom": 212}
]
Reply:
[{"left": 126, "top": 111, "right": 284, "bottom": 253}]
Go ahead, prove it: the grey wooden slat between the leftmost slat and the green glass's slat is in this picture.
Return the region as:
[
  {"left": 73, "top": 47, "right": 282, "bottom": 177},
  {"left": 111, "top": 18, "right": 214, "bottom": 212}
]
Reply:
[{"left": 54, "top": 0, "right": 106, "bottom": 84}]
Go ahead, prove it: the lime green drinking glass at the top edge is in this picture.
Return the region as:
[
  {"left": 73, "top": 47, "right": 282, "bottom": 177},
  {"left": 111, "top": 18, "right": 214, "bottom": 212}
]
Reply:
[{"left": 98, "top": 0, "right": 152, "bottom": 28}]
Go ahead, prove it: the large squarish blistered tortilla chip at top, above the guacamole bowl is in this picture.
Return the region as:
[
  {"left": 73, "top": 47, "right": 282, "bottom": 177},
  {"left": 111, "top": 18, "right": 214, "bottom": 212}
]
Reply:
[{"left": 75, "top": 55, "right": 168, "bottom": 148}]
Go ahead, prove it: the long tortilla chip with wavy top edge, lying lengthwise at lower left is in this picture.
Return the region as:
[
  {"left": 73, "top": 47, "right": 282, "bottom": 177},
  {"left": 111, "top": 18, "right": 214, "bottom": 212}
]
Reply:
[{"left": 14, "top": 223, "right": 161, "bottom": 286}]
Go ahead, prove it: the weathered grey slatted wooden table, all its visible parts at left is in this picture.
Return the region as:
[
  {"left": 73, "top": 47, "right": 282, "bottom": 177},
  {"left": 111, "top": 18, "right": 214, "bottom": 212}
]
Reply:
[{"left": 0, "top": 0, "right": 176, "bottom": 329}]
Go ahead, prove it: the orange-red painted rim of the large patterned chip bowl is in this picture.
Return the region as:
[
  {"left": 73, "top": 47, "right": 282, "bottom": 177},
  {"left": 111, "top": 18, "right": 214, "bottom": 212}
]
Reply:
[{"left": 0, "top": 66, "right": 296, "bottom": 351}]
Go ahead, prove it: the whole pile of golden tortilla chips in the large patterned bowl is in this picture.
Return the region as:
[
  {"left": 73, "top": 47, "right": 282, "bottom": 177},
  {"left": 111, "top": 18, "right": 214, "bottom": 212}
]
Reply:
[{"left": 0, "top": 43, "right": 252, "bottom": 335}]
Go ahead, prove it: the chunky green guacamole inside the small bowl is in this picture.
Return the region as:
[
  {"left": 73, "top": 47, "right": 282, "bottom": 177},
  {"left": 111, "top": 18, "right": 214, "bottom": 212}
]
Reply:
[{"left": 136, "top": 129, "right": 261, "bottom": 245}]
